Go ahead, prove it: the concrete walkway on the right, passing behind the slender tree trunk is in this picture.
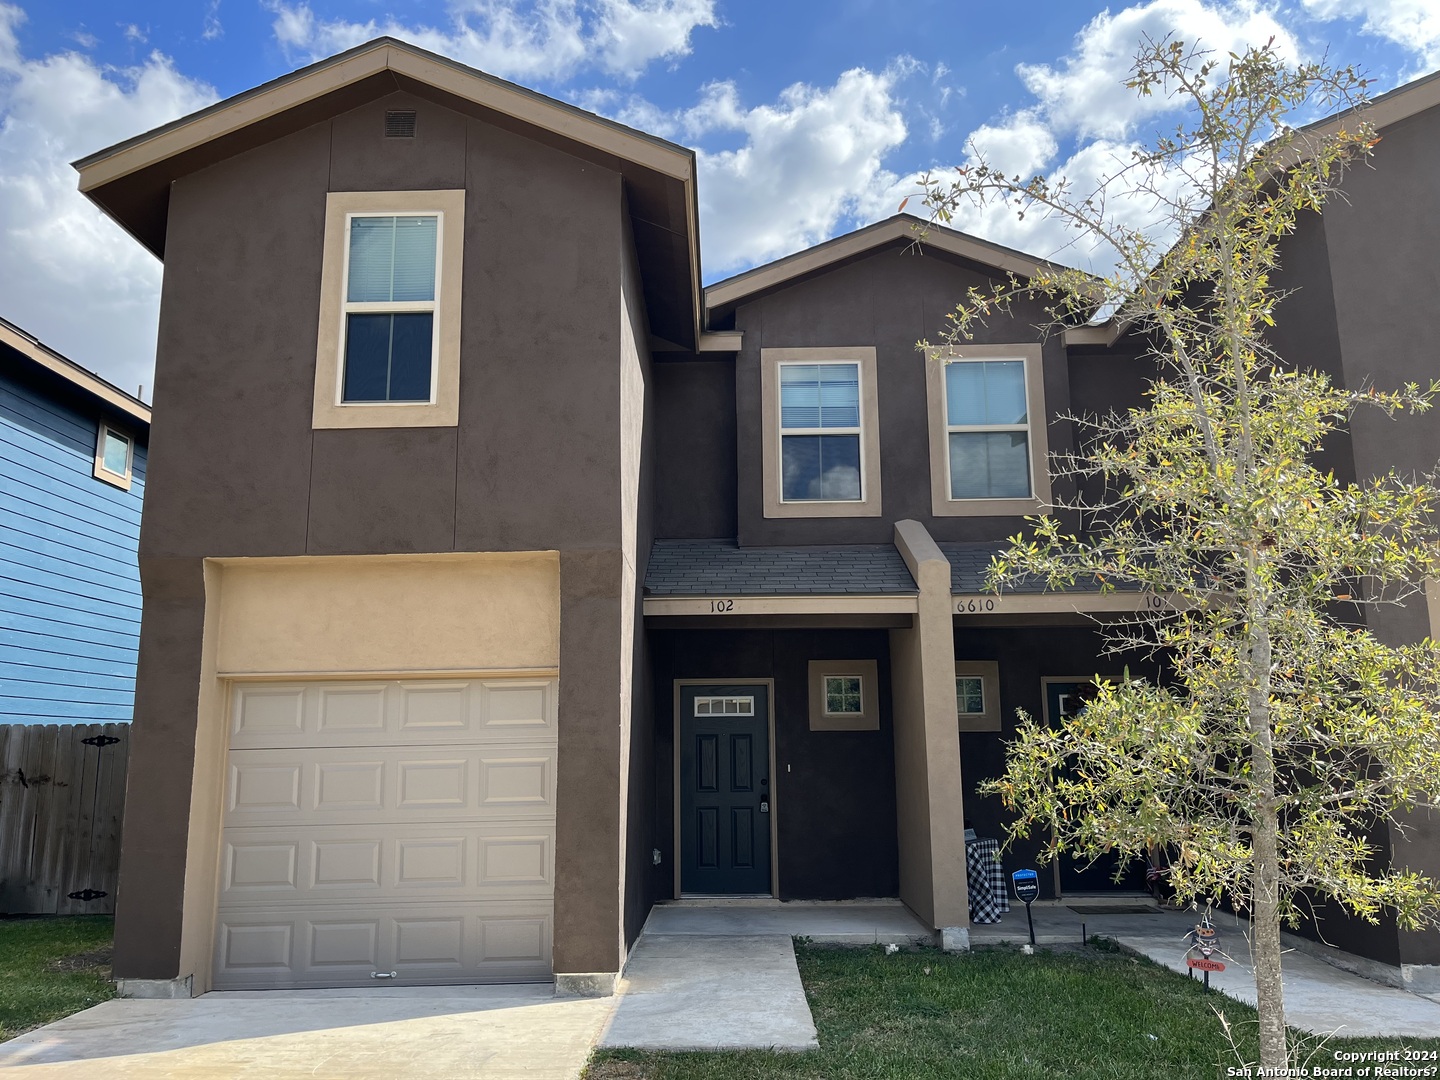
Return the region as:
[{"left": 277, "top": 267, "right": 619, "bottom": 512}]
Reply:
[{"left": 971, "top": 904, "right": 1440, "bottom": 1038}]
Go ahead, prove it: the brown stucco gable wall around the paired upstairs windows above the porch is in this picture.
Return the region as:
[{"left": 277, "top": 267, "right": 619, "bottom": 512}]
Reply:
[{"left": 734, "top": 246, "right": 1071, "bottom": 546}]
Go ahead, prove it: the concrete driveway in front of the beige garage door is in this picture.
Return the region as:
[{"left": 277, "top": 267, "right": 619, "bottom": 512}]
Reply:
[{"left": 0, "top": 985, "right": 615, "bottom": 1080}]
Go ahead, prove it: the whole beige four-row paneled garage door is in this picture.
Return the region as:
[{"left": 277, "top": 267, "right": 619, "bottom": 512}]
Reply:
[{"left": 213, "top": 680, "right": 556, "bottom": 989}]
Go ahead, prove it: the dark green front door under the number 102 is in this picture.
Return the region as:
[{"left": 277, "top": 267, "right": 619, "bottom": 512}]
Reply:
[{"left": 680, "top": 684, "right": 770, "bottom": 896}]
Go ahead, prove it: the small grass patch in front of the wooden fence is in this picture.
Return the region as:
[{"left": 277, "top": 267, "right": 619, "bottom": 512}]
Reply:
[{"left": 0, "top": 914, "right": 115, "bottom": 1040}]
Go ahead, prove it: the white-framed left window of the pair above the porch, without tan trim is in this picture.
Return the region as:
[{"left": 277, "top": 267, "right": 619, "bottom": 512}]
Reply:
[{"left": 780, "top": 363, "right": 864, "bottom": 503}]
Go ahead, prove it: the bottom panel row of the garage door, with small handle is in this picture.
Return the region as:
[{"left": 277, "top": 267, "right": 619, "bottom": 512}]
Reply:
[{"left": 215, "top": 900, "right": 554, "bottom": 989}]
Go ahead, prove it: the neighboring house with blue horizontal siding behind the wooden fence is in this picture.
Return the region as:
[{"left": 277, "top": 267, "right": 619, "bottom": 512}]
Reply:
[{"left": 0, "top": 318, "right": 150, "bottom": 724}]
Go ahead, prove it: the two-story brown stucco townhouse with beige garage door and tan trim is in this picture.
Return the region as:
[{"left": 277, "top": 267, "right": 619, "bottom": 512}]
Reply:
[{"left": 78, "top": 39, "right": 1440, "bottom": 994}]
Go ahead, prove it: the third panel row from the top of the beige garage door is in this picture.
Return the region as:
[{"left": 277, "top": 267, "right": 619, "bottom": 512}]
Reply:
[{"left": 220, "top": 821, "right": 554, "bottom": 910}]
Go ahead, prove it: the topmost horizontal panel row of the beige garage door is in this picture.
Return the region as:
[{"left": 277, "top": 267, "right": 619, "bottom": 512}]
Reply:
[{"left": 230, "top": 680, "right": 557, "bottom": 750}]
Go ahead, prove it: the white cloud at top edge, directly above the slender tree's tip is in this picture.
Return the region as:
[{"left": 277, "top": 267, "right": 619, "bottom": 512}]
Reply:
[{"left": 1015, "top": 0, "right": 1301, "bottom": 138}]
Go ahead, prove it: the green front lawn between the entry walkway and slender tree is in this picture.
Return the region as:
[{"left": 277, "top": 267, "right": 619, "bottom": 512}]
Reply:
[{"left": 585, "top": 945, "right": 1440, "bottom": 1080}]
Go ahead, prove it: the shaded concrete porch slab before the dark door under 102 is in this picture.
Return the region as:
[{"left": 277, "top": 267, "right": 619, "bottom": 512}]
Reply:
[{"left": 645, "top": 900, "right": 935, "bottom": 945}]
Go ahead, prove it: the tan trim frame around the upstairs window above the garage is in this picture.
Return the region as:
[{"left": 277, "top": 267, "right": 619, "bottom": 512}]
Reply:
[{"left": 311, "top": 190, "right": 465, "bottom": 428}]
